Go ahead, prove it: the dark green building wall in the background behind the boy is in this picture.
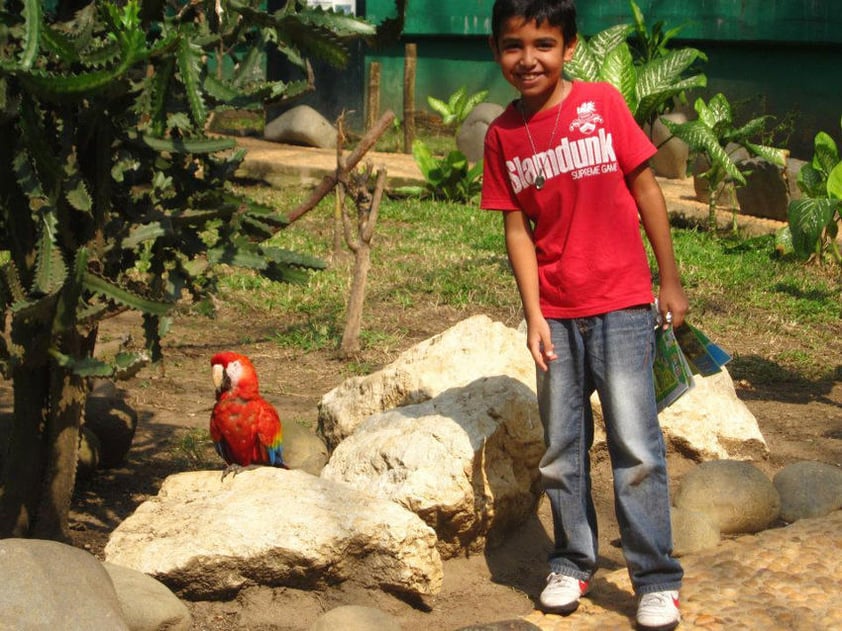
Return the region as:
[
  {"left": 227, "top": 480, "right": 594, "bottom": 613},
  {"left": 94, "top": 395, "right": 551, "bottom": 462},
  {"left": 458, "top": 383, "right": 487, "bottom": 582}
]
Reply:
[{"left": 356, "top": 0, "right": 842, "bottom": 158}]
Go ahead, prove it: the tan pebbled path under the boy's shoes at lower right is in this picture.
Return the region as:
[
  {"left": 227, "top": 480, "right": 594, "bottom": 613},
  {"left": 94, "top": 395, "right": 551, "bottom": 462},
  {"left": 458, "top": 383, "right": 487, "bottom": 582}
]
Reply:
[{"left": 525, "top": 511, "right": 842, "bottom": 631}]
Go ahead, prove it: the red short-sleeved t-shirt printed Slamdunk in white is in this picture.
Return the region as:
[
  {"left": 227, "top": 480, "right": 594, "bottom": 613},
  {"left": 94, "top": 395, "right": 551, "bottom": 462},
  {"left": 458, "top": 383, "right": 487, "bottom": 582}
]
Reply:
[{"left": 481, "top": 81, "right": 655, "bottom": 318}]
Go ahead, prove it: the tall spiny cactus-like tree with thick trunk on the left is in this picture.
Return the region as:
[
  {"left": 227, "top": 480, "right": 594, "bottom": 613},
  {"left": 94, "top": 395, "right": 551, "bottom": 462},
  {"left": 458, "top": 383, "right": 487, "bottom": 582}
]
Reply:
[{"left": 0, "top": 0, "right": 374, "bottom": 539}]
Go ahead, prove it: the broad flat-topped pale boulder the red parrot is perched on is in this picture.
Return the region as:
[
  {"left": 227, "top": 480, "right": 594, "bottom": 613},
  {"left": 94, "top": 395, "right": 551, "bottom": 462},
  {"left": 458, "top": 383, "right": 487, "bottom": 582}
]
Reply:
[{"left": 105, "top": 467, "right": 442, "bottom": 599}]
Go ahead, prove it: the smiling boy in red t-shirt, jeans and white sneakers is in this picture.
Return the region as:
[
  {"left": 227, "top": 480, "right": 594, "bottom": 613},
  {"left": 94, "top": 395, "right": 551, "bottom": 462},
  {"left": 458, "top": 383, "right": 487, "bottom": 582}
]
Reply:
[{"left": 481, "top": 0, "right": 688, "bottom": 630}]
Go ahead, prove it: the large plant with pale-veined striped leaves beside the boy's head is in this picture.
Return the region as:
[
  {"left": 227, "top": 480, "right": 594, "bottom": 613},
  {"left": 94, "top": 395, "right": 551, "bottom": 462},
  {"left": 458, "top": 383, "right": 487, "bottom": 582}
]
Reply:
[{"left": 564, "top": 2, "right": 707, "bottom": 129}]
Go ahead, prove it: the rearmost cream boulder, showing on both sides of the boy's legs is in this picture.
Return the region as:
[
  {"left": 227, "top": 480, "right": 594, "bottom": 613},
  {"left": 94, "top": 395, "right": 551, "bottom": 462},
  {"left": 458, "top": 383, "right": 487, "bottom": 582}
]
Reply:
[{"left": 319, "top": 315, "right": 769, "bottom": 461}]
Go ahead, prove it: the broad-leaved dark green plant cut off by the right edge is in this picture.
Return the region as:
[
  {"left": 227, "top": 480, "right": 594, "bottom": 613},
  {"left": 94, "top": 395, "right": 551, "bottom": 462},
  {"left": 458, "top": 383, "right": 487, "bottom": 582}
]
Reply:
[{"left": 784, "top": 120, "right": 842, "bottom": 263}]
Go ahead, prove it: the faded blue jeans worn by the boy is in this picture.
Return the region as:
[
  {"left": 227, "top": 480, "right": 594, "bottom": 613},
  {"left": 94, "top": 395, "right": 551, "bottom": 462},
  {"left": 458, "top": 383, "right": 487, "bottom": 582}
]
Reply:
[{"left": 538, "top": 306, "right": 683, "bottom": 594}]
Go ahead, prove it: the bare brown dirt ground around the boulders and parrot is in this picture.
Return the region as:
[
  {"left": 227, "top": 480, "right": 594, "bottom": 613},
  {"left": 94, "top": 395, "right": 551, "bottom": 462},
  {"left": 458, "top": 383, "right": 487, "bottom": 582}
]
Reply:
[{"left": 0, "top": 185, "right": 842, "bottom": 631}]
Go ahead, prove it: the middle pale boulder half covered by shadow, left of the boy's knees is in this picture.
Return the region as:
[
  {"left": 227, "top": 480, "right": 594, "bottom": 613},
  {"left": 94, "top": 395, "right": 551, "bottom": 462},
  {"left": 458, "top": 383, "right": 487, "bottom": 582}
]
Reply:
[{"left": 322, "top": 376, "right": 544, "bottom": 558}]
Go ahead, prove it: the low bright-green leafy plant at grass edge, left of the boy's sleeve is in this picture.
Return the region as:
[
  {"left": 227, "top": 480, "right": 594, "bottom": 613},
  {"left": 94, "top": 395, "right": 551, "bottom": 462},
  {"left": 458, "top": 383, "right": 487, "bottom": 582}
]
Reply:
[{"left": 394, "top": 139, "right": 482, "bottom": 203}]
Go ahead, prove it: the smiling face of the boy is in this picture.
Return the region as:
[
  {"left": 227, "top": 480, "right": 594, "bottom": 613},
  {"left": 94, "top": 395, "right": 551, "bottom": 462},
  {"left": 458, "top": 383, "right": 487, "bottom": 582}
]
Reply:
[{"left": 491, "top": 17, "right": 576, "bottom": 114}]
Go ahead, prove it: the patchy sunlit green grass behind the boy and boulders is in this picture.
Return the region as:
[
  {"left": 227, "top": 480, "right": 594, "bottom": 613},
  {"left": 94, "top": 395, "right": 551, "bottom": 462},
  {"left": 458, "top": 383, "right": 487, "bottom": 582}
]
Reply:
[{"left": 218, "top": 178, "right": 842, "bottom": 380}]
